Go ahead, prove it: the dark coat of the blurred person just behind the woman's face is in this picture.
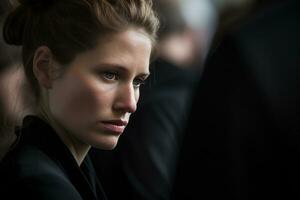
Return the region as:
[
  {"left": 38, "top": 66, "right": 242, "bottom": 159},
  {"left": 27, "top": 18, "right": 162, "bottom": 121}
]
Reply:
[{"left": 91, "top": 59, "right": 200, "bottom": 200}]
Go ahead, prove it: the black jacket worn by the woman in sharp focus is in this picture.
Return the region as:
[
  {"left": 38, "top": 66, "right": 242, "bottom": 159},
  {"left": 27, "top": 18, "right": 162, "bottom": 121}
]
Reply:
[{"left": 0, "top": 116, "right": 106, "bottom": 200}]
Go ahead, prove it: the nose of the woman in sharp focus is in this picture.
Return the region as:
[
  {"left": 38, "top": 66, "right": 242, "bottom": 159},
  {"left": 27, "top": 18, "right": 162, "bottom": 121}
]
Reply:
[{"left": 113, "top": 84, "right": 139, "bottom": 113}]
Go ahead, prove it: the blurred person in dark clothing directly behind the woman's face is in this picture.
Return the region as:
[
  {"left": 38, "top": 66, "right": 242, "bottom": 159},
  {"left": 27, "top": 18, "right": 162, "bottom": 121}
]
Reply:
[{"left": 93, "top": 0, "right": 200, "bottom": 200}]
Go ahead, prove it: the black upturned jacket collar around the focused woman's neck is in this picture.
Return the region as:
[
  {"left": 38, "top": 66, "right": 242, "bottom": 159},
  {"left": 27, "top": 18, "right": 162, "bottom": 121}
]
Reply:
[{"left": 19, "top": 116, "right": 106, "bottom": 199}]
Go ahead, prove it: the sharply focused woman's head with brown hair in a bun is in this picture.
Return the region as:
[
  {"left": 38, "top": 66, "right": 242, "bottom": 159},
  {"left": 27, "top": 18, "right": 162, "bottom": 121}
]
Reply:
[{"left": 4, "top": 0, "right": 158, "bottom": 149}]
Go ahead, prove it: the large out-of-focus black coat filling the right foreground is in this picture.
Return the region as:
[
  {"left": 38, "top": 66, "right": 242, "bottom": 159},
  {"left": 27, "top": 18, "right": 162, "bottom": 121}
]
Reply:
[{"left": 173, "top": 0, "right": 300, "bottom": 200}]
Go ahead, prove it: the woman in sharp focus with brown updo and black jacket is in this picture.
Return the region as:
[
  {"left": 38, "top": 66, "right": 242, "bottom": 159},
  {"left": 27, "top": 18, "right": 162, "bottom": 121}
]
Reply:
[{"left": 0, "top": 0, "right": 158, "bottom": 200}]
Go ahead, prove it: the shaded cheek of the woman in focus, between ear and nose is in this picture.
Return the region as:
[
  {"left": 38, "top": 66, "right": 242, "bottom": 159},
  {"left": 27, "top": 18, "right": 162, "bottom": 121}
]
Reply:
[{"left": 51, "top": 75, "right": 109, "bottom": 123}]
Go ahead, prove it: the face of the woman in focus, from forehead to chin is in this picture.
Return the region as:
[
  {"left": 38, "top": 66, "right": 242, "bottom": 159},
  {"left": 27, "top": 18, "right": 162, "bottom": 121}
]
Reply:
[{"left": 48, "top": 29, "right": 152, "bottom": 149}]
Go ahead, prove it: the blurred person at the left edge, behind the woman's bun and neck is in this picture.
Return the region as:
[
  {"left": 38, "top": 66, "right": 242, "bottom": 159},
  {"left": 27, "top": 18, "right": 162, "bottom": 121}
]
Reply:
[{"left": 0, "top": 0, "right": 32, "bottom": 160}]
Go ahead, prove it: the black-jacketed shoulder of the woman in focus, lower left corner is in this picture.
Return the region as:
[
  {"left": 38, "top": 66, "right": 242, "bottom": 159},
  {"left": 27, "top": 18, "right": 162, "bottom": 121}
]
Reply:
[{"left": 0, "top": 145, "right": 81, "bottom": 200}]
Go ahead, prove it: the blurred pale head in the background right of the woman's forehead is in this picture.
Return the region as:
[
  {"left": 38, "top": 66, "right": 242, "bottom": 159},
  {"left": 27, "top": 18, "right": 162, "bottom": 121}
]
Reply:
[{"left": 153, "top": 0, "right": 200, "bottom": 67}]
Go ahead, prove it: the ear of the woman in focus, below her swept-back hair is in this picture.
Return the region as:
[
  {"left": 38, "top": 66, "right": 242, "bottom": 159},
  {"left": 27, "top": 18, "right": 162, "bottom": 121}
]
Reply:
[{"left": 33, "top": 46, "right": 54, "bottom": 89}]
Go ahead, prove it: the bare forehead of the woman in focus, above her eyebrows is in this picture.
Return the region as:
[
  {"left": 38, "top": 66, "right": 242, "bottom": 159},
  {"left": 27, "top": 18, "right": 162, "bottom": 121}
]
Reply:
[{"left": 70, "top": 29, "right": 152, "bottom": 72}]
